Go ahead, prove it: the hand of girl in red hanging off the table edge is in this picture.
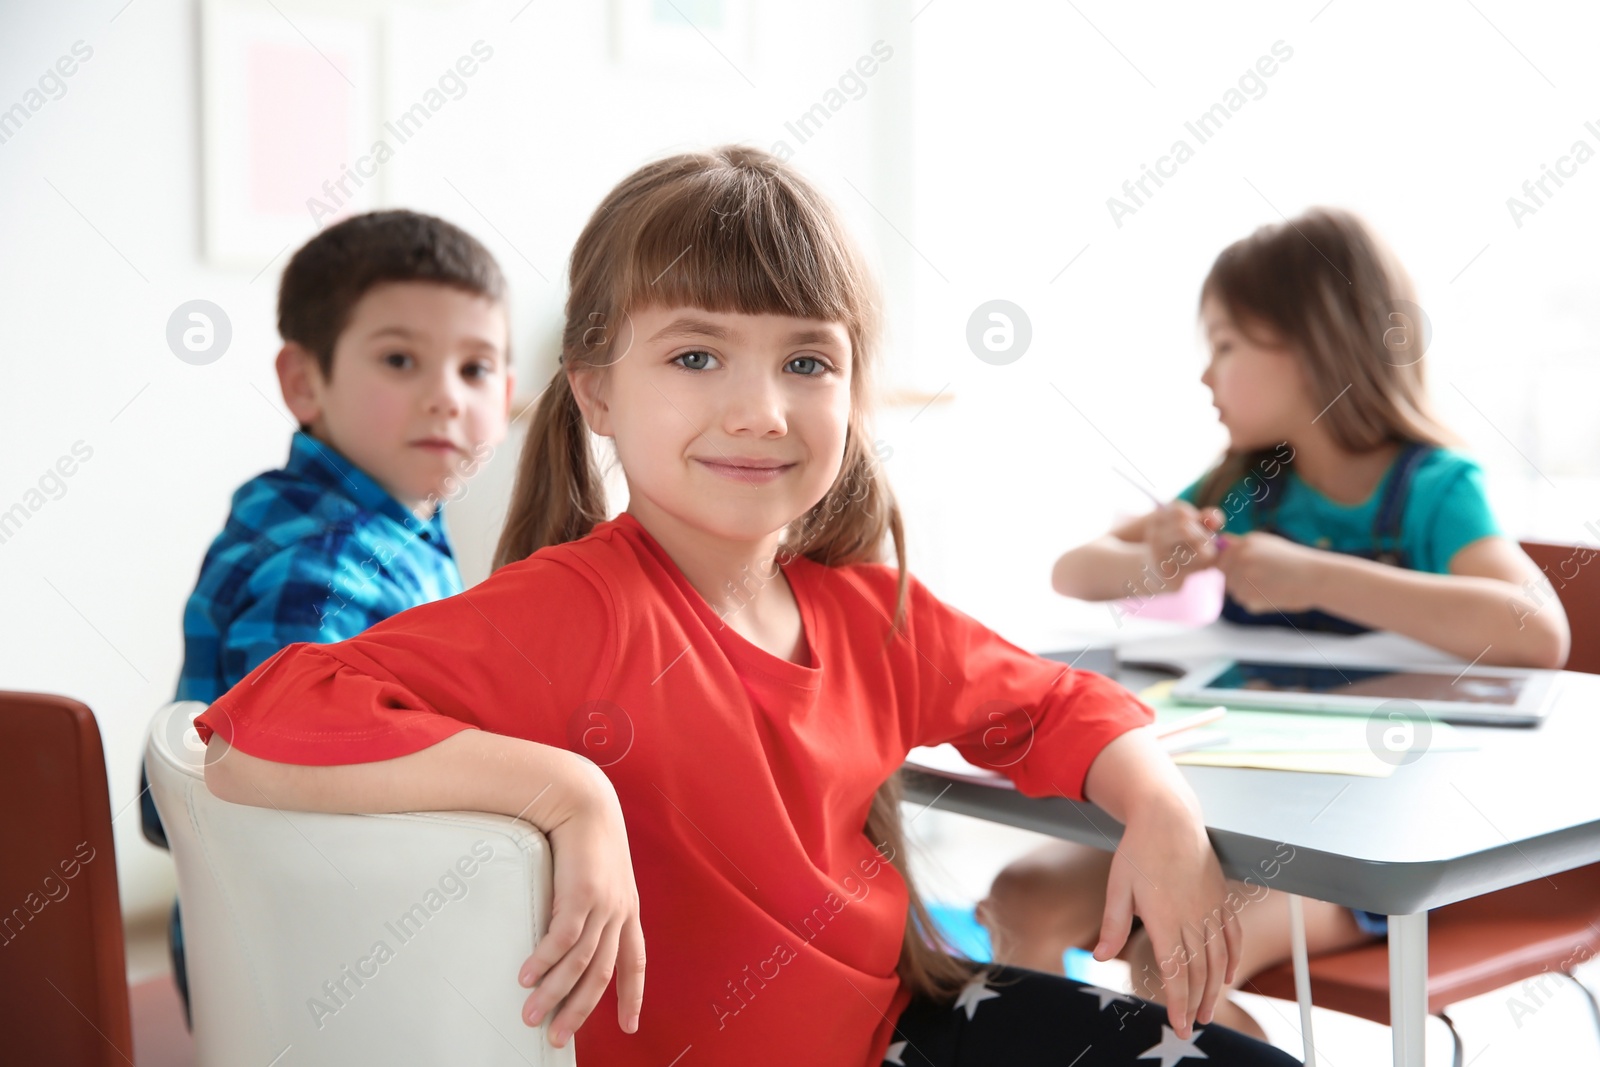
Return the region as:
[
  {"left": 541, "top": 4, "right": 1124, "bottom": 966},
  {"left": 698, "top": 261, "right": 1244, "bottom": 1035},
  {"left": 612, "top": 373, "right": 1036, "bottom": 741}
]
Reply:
[{"left": 1094, "top": 792, "right": 1245, "bottom": 1038}]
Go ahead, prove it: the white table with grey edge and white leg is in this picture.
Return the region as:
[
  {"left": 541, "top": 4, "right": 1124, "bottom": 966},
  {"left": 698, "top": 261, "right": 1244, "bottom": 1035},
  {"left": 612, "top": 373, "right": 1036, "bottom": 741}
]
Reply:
[{"left": 906, "top": 652, "right": 1600, "bottom": 1067}]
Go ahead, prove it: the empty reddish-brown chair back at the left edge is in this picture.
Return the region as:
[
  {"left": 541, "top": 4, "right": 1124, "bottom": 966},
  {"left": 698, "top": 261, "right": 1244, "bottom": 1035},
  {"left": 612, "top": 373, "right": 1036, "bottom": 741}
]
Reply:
[{"left": 0, "top": 693, "right": 133, "bottom": 1067}]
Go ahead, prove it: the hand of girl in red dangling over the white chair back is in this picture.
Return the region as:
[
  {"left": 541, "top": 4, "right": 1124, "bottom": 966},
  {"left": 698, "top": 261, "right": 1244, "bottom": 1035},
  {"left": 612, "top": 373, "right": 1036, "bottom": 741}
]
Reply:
[{"left": 518, "top": 769, "right": 645, "bottom": 1048}]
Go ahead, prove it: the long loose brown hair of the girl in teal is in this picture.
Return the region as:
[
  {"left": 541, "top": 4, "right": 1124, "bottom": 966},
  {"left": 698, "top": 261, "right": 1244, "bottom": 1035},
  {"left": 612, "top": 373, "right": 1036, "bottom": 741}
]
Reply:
[{"left": 1198, "top": 208, "right": 1458, "bottom": 507}]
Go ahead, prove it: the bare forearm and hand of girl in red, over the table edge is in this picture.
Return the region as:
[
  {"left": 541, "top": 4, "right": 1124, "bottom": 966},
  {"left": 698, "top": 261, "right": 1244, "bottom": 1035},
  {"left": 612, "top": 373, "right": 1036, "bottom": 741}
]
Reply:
[{"left": 1083, "top": 728, "right": 1243, "bottom": 1037}]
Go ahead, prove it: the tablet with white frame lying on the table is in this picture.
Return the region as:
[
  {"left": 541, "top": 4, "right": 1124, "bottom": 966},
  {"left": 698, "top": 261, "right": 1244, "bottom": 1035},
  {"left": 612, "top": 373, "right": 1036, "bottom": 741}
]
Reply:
[{"left": 1173, "top": 659, "right": 1562, "bottom": 726}]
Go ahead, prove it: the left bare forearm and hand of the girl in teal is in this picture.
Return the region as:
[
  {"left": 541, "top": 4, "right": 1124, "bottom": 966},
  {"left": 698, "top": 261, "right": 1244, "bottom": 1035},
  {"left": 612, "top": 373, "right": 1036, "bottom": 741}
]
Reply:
[{"left": 1050, "top": 501, "right": 1222, "bottom": 600}]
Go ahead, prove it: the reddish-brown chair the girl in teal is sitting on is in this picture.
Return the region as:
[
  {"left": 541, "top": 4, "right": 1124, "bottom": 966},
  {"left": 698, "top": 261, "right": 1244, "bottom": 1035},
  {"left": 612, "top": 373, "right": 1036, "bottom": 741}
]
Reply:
[{"left": 1245, "top": 541, "right": 1600, "bottom": 1067}]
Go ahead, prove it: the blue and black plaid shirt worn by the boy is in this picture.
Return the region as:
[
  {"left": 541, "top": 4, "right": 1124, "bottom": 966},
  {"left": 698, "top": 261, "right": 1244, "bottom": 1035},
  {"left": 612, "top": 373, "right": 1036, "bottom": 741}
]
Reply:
[{"left": 176, "top": 432, "right": 461, "bottom": 704}]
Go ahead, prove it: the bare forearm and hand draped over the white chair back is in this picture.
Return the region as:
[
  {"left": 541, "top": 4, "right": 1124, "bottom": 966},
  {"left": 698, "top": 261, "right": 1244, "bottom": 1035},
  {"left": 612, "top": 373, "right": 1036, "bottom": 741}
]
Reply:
[{"left": 205, "top": 729, "right": 645, "bottom": 1048}]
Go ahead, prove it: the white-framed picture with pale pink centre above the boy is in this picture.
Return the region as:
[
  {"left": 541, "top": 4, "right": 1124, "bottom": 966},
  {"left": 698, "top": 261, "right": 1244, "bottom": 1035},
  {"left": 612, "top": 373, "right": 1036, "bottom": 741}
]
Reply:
[{"left": 200, "top": 0, "right": 392, "bottom": 270}]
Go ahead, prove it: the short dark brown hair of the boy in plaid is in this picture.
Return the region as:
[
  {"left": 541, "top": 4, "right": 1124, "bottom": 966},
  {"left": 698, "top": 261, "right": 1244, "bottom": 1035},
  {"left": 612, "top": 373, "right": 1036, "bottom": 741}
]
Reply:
[{"left": 278, "top": 211, "right": 506, "bottom": 381}]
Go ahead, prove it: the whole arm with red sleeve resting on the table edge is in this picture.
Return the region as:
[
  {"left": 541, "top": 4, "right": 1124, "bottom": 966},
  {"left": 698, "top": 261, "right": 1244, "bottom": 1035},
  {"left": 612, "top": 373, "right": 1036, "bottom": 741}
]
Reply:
[{"left": 902, "top": 568, "right": 1242, "bottom": 1035}]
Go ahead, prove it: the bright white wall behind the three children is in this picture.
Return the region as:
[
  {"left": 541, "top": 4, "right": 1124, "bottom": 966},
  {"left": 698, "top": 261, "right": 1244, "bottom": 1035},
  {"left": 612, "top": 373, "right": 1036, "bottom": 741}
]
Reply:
[{"left": 0, "top": 0, "right": 1600, "bottom": 927}]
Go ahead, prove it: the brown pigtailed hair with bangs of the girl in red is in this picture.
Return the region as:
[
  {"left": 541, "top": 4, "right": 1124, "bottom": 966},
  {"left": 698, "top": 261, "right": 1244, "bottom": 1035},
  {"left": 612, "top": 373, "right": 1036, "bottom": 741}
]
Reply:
[{"left": 494, "top": 146, "right": 973, "bottom": 998}]
